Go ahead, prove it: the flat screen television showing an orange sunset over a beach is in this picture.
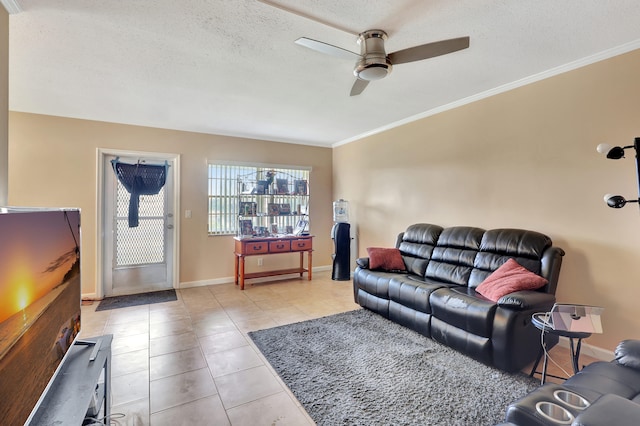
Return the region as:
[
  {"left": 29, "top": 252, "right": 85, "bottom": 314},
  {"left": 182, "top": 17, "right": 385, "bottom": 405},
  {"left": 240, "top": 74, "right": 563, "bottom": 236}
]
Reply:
[{"left": 0, "top": 207, "right": 81, "bottom": 425}]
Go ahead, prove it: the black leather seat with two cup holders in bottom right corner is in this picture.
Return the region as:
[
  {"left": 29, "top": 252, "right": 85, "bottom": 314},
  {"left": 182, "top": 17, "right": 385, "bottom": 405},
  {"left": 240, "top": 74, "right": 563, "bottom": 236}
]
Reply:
[{"left": 504, "top": 340, "right": 640, "bottom": 426}]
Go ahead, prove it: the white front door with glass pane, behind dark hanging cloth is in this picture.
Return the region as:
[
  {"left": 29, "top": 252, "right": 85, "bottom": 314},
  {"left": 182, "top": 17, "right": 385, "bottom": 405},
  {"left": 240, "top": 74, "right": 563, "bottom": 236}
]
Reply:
[{"left": 101, "top": 153, "right": 177, "bottom": 297}]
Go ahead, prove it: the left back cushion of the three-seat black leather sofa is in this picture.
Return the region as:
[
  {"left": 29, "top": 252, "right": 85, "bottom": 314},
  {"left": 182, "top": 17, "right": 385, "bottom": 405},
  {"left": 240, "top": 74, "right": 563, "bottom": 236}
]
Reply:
[{"left": 397, "top": 223, "right": 443, "bottom": 277}]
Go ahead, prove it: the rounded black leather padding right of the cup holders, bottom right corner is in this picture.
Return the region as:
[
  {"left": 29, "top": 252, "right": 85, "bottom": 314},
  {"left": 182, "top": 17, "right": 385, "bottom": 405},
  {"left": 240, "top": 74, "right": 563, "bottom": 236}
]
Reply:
[{"left": 571, "top": 394, "right": 640, "bottom": 426}]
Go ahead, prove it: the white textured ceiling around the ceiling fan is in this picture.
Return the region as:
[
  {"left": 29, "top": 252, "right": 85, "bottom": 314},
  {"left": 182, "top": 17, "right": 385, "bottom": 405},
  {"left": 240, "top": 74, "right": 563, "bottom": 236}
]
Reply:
[{"left": 9, "top": 0, "right": 640, "bottom": 146}]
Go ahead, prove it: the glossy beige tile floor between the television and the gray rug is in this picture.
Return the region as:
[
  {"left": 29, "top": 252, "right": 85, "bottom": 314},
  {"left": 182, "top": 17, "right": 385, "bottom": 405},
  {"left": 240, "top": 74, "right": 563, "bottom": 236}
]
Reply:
[{"left": 81, "top": 272, "right": 590, "bottom": 426}]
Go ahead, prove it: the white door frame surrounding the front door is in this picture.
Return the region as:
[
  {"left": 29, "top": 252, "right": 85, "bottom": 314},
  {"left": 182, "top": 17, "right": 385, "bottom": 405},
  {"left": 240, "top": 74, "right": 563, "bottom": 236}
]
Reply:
[{"left": 96, "top": 148, "right": 182, "bottom": 299}]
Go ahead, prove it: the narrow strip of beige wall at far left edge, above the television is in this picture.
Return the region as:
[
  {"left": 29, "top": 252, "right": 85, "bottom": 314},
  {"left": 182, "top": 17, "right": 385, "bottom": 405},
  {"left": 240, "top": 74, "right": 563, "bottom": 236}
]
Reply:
[{"left": 0, "top": 7, "right": 9, "bottom": 206}]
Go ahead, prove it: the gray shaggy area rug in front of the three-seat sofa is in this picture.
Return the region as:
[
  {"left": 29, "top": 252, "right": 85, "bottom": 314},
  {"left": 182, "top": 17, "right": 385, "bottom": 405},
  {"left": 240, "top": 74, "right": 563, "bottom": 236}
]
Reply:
[{"left": 249, "top": 309, "right": 539, "bottom": 426}]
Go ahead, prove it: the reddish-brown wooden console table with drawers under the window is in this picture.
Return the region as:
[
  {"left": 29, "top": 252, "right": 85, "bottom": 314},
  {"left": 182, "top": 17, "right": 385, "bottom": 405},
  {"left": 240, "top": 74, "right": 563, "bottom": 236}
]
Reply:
[{"left": 234, "top": 235, "right": 313, "bottom": 290}]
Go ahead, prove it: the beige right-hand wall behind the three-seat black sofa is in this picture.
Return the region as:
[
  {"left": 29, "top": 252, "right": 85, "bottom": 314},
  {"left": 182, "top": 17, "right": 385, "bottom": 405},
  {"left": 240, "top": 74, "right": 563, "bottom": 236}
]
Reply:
[{"left": 333, "top": 51, "right": 640, "bottom": 350}]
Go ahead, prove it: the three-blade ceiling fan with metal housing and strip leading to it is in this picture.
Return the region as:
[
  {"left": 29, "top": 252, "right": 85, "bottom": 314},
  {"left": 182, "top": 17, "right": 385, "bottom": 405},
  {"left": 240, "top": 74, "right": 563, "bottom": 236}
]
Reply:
[{"left": 258, "top": 0, "right": 469, "bottom": 96}]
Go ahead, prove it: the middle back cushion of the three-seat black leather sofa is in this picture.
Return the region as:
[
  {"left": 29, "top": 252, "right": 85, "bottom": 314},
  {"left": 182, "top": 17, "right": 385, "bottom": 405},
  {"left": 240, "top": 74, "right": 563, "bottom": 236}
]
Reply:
[{"left": 424, "top": 226, "right": 484, "bottom": 286}]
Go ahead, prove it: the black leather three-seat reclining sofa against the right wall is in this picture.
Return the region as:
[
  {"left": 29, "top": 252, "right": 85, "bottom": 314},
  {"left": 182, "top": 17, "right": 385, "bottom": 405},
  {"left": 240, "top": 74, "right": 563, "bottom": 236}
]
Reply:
[{"left": 353, "top": 223, "right": 564, "bottom": 372}]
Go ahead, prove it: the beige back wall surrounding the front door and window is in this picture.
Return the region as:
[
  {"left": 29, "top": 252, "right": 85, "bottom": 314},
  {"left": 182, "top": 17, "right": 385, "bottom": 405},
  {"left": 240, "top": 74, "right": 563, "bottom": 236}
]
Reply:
[{"left": 9, "top": 112, "right": 333, "bottom": 294}]
